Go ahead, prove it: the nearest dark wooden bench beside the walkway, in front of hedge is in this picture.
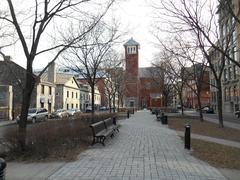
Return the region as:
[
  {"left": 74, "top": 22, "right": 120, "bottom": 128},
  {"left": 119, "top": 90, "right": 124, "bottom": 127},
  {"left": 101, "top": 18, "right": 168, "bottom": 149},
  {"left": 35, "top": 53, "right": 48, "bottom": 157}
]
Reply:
[{"left": 90, "top": 118, "right": 119, "bottom": 146}]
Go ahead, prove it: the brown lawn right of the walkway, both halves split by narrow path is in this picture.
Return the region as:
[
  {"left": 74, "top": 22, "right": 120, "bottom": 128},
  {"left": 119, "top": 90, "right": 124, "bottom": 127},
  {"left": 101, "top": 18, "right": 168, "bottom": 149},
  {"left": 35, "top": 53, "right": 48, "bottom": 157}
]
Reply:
[{"left": 168, "top": 116, "right": 240, "bottom": 170}]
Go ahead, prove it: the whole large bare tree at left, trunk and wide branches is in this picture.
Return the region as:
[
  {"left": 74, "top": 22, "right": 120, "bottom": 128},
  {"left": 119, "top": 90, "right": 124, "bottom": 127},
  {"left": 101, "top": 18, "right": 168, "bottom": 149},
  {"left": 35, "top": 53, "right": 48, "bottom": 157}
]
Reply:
[{"left": 0, "top": 0, "right": 114, "bottom": 150}]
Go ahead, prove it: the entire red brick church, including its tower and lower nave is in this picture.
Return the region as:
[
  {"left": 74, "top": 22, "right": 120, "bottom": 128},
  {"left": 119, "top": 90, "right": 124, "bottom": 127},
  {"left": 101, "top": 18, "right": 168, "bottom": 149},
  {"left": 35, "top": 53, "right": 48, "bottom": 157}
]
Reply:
[{"left": 124, "top": 38, "right": 164, "bottom": 108}]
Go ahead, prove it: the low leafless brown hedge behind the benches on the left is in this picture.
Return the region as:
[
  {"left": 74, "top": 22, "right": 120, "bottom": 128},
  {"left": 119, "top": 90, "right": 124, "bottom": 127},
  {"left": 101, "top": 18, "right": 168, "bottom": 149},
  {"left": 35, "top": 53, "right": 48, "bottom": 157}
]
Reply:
[{"left": 2, "top": 113, "right": 114, "bottom": 160}]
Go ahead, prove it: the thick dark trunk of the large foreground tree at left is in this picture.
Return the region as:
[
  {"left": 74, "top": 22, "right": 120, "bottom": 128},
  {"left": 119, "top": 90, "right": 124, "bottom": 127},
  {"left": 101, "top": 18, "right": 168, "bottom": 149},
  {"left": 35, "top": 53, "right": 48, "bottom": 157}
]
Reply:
[{"left": 18, "top": 65, "right": 35, "bottom": 151}]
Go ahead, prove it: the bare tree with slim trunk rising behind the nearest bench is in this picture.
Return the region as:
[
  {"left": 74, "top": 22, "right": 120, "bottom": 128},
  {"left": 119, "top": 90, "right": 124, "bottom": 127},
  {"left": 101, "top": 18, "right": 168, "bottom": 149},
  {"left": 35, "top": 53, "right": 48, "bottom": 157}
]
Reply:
[{"left": 64, "top": 22, "right": 119, "bottom": 120}]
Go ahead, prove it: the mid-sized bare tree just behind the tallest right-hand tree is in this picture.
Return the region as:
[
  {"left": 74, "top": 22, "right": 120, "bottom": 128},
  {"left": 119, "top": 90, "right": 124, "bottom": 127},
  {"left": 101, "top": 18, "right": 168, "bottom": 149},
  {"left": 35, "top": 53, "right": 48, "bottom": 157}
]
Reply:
[{"left": 156, "top": 36, "right": 209, "bottom": 121}]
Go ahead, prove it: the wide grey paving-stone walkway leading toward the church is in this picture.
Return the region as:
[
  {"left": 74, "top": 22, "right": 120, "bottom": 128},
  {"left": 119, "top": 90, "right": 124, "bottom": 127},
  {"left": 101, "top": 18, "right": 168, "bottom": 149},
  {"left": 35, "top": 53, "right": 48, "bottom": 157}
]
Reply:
[{"left": 48, "top": 111, "right": 225, "bottom": 180}]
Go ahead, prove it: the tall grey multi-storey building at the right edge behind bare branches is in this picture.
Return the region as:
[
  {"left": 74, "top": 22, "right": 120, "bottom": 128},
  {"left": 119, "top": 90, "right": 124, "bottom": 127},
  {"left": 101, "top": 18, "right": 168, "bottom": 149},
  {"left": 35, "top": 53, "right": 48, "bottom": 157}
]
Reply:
[{"left": 209, "top": 0, "right": 240, "bottom": 112}]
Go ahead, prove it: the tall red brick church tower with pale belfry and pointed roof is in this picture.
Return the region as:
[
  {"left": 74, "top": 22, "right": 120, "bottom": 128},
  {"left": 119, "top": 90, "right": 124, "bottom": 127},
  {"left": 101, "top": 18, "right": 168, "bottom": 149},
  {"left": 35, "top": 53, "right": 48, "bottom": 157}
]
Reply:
[{"left": 123, "top": 38, "right": 140, "bottom": 108}]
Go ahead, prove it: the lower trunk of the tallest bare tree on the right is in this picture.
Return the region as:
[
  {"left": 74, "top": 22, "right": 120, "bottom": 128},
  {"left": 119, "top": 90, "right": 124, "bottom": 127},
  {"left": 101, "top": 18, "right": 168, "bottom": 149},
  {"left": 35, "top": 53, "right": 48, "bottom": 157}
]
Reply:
[{"left": 216, "top": 79, "right": 224, "bottom": 128}]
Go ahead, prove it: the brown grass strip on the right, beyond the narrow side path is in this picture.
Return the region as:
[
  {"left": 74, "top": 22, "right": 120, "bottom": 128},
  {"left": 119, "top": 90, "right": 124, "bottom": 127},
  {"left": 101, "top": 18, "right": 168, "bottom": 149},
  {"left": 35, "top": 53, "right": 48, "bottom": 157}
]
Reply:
[{"left": 168, "top": 116, "right": 240, "bottom": 142}]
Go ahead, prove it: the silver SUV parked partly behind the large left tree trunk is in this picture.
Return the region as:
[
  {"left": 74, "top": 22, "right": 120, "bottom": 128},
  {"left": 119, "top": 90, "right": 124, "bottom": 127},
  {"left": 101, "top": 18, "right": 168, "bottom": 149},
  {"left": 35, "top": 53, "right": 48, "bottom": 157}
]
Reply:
[{"left": 16, "top": 108, "right": 48, "bottom": 123}]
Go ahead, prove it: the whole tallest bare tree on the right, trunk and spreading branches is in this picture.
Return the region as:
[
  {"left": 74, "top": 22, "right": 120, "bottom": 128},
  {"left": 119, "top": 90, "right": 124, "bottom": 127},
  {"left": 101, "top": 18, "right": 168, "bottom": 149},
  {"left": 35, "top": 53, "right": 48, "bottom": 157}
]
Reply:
[{"left": 150, "top": 0, "right": 240, "bottom": 127}]
